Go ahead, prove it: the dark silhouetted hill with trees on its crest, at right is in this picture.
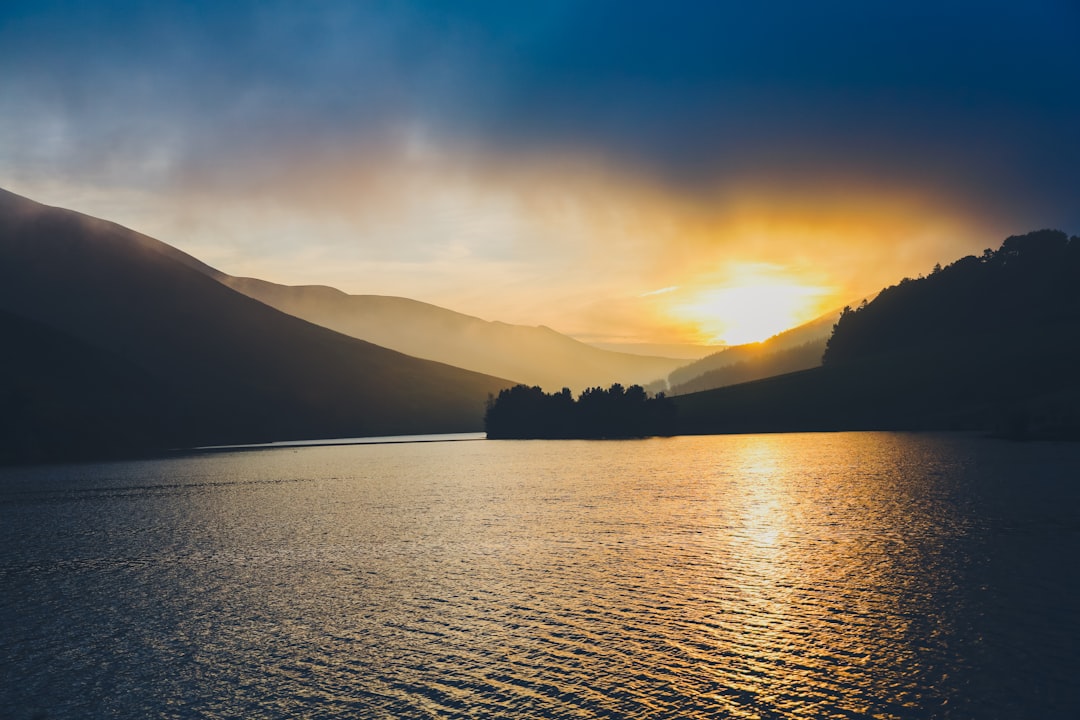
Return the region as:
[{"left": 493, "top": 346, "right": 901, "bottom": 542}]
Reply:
[{"left": 674, "top": 230, "right": 1080, "bottom": 438}]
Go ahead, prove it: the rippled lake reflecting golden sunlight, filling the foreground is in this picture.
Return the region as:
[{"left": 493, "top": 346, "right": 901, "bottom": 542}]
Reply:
[{"left": 0, "top": 433, "right": 1080, "bottom": 719}]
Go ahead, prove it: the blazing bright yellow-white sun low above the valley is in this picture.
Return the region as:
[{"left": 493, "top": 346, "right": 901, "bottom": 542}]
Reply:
[{"left": 674, "top": 277, "right": 829, "bottom": 345}]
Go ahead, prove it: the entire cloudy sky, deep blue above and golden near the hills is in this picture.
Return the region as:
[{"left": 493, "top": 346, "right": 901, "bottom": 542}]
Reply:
[{"left": 0, "top": 0, "right": 1080, "bottom": 344}]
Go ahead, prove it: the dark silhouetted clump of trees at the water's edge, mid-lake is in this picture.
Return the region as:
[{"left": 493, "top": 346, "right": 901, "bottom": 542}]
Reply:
[{"left": 484, "top": 383, "right": 676, "bottom": 439}]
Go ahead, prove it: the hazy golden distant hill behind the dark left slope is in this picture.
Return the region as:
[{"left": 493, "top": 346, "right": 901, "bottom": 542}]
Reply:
[{"left": 214, "top": 278, "right": 686, "bottom": 392}]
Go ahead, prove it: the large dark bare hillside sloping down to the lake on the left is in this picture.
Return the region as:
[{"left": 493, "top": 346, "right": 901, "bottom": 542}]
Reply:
[{"left": 0, "top": 190, "right": 512, "bottom": 460}]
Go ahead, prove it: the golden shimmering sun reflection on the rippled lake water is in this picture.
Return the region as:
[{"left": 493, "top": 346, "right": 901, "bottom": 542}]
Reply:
[{"left": 669, "top": 435, "right": 976, "bottom": 718}]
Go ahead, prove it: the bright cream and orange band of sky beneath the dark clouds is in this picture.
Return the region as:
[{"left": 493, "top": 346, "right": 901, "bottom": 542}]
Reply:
[{"left": 4, "top": 151, "right": 996, "bottom": 345}]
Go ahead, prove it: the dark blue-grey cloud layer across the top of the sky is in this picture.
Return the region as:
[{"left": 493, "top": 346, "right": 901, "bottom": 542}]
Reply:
[{"left": 0, "top": 0, "right": 1080, "bottom": 225}]
